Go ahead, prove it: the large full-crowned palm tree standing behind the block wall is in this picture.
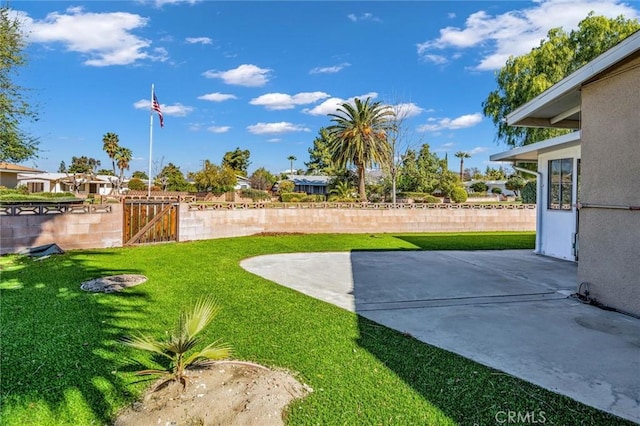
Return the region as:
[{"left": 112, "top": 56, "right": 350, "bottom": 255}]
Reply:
[{"left": 327, "top": 98, "right": 394, "bottom": 201}]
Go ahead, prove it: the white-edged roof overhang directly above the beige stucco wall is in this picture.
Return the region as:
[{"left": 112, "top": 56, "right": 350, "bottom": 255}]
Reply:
[{"left": 507, "top": 31, "right": 640, "bottom": 129}]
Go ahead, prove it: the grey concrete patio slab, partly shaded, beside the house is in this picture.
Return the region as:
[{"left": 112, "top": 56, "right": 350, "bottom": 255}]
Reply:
[{"left": 241, "top": 250, "right": 640, "bottom": 423}]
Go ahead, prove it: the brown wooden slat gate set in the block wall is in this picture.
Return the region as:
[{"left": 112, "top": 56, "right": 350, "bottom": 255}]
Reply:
[{"left": 122, "top": 198, "right": 180, "bottom": 246}]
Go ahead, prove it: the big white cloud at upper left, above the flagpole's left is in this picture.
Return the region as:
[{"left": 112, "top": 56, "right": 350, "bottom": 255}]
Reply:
[{"left": 20, "top": 7, "right": 168, "bottom": 67}]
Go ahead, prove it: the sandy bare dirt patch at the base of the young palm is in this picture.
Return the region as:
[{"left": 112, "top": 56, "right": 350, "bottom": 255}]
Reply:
[{"left": 114, "top": 361, "right": 312, "bottom": 426}]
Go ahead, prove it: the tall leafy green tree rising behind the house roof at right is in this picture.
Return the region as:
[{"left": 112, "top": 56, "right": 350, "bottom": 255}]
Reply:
[{"left": 482, "top": 13, "right": 640, "bottom": 146}]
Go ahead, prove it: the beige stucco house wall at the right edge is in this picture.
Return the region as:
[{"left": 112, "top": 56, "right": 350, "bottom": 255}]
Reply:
[{"left": 578, "top": 54, "right": 640, "bottom": 315}]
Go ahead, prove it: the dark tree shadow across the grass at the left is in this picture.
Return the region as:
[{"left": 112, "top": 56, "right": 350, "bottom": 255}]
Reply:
[{"left": 0, "top": 251, "right": 149, "bottom": 425}]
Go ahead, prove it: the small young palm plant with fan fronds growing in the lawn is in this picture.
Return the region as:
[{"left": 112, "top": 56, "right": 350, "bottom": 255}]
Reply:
[{"left": 122, "top": 297, "right": 231, "bottom": 388}]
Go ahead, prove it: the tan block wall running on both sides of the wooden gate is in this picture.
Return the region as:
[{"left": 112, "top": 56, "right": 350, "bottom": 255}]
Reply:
[{"left": 0, "top": 203, "right": 536, "bottom": 254}]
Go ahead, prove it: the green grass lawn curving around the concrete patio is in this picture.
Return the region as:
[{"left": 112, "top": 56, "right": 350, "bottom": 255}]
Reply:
[{"left": 0, "top": 233, "right": 631, "bottom": 426}]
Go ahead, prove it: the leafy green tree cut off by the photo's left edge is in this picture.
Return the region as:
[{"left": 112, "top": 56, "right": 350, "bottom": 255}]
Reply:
[{"left": 0, "top": 5, "right": 39, "bottom": 163}]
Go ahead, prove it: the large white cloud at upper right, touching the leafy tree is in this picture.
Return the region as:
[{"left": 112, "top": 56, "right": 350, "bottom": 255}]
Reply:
[{"left": 417, "top": 0, "right": 639, "bottom": 70}]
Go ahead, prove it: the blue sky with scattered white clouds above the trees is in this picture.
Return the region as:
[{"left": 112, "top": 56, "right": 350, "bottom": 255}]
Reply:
[{"left": 10, "top": 0, "right": 640, "bottom": 173}]
